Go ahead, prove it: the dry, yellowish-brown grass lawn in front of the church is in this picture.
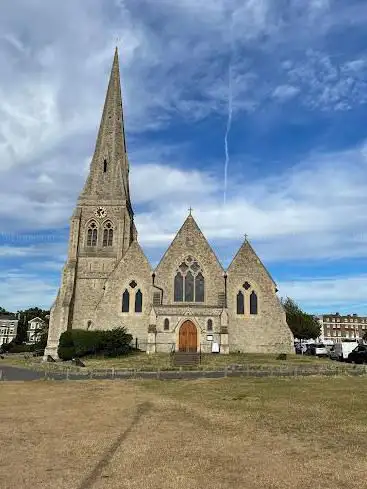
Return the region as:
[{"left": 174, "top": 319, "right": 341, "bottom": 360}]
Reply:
[{"left": 0, "top": 377, "right": 367, "bottom": 489}]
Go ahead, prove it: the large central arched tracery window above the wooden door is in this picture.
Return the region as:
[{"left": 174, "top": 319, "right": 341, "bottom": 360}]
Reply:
[{"left": 173, "top": 256, "right": 205, "bottom": 302}]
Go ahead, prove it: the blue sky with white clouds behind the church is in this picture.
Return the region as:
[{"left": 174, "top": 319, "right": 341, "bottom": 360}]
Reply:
[{"left": 0, "top": 0, "right": 367, "bottom": 314}]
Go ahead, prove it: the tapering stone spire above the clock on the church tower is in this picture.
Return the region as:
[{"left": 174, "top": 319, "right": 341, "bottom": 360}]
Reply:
[{"left": 79, "top": 47, "right": 132, "bottom": 213}]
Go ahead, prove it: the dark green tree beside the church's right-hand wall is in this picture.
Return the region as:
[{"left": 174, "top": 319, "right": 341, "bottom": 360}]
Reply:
[{"left": 281, "top": 297, "right": 320, "bottom": 340}]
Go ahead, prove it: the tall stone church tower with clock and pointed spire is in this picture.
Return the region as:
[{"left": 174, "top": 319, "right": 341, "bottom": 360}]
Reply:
[{"left": 45, "top": 48, "right": 137, "bottom": 357}]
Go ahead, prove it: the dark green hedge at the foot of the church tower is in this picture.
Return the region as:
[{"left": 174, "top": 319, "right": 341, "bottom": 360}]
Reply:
[{"left": 58, "top": 328, "right": 132, "bottom": 360}]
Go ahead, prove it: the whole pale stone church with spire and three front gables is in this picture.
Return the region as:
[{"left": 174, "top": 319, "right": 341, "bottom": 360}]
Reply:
[{"left": 45, "top": 49, "right": 294, "bottom": 358}]
